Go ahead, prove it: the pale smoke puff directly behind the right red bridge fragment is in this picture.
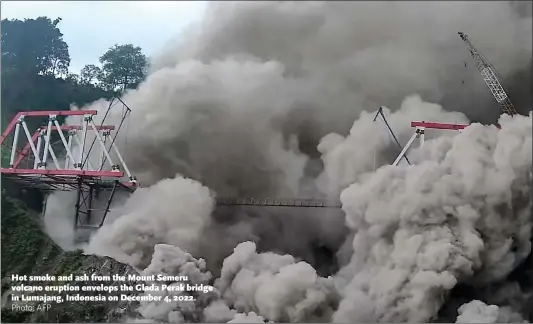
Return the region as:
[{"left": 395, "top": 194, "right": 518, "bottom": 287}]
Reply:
[{"left": 318, "top": 96, "right": 468, "bottom": 197}]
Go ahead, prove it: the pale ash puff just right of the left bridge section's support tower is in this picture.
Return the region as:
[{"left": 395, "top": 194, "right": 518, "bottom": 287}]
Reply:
[{"left": 86, "top": 176, "right": 214, "bottom": 269}]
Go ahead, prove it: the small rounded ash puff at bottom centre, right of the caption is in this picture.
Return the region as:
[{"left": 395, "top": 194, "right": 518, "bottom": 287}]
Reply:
[{"left": 215, "top": 242, "right": 338, "bottom": 322}]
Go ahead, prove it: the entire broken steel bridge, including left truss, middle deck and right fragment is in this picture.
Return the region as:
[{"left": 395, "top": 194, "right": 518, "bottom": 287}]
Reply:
[{"left": 1, "top": 98, "right": 482, "bottom": 232}]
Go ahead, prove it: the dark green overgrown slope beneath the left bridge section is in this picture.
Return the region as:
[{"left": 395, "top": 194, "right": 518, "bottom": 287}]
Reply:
[{"left": 1, "top": 192, "right": 141, "bottom": 323}]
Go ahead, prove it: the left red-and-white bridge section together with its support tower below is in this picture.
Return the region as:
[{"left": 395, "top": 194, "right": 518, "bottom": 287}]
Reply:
[{"left": 0, "top": 99, "right": 137, "bottom": 227}]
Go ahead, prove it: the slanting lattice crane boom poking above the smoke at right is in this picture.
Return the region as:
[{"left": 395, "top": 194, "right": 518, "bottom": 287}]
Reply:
[{"left": 458, "top": 32, "right": 517, "bottom": 116}]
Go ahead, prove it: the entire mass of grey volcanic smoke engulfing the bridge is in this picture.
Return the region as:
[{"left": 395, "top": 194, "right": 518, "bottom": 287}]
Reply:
[{"left": 39, "top": 2, "right": 532, "bottom": 323}]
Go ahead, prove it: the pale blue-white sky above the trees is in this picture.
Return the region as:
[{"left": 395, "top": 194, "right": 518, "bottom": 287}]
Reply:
[{"left": 0, "top": 1, "right": 206, "bottom": 73}]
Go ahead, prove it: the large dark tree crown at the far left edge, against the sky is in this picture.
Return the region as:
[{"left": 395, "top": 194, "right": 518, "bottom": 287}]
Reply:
[{"left": 1, "top": 17, "right": 70, "bottom": 75}]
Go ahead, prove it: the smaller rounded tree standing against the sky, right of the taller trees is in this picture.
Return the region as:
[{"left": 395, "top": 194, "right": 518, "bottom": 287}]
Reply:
[{"left": 100, "top": 44, "right": 147, "bottom": 91}]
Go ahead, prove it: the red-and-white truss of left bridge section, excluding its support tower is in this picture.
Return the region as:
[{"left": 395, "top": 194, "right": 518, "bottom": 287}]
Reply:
[{"left": 0, "top": 110, "right": 135, "bottom": 184}]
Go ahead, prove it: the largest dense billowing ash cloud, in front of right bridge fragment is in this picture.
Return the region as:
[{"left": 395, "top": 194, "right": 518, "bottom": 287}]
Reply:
[{"left": 334, "top": 115, "right": 532, "bottom": 322}]
